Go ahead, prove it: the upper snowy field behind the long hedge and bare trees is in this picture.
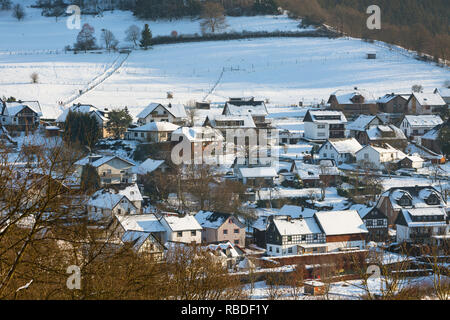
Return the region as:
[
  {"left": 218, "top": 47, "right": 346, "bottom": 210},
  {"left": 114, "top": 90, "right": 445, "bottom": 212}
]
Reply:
[{"left": 0, "top": 0, "right": 306, "bottom": 52}]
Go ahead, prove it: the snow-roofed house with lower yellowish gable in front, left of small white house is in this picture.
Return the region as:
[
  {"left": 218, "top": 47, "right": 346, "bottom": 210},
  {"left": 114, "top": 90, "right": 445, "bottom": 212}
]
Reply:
[{"left": 110, "top": 214, "right": 166, "bottom": 261}]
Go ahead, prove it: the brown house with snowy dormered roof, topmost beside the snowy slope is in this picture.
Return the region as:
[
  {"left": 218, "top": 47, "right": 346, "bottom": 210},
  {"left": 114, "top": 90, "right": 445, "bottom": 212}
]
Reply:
[{"left": 328, "top": 88, "right": 378, "bottom": 116}]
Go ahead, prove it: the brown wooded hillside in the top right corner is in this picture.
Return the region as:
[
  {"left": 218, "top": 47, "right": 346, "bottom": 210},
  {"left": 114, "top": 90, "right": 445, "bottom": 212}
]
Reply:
[{"left": 277, "top": 0, "right": 450, "bottom": 61}]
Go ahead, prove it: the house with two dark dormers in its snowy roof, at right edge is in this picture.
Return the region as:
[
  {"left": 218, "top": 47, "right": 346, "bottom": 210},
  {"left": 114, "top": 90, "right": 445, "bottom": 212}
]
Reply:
[{"left": 376, "top": 186, "right": 446, "bottom": 225}]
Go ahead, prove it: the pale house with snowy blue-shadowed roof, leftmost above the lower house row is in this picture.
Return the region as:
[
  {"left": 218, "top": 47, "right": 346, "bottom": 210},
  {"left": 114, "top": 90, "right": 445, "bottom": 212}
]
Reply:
[{"left": 86, "top": 189, "right": 140, "bottom": 220}]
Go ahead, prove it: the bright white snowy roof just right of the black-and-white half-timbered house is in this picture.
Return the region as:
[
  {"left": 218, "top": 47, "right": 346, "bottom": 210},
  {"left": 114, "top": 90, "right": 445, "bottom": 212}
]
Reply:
[{"left": 315, "top": 210, "right": 368, "bottom": 236}]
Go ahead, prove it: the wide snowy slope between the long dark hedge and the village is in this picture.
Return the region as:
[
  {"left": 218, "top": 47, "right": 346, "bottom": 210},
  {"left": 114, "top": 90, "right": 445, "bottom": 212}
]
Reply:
[{"left": 0, "top": 38, "right": 450, "bottom": 120}]
